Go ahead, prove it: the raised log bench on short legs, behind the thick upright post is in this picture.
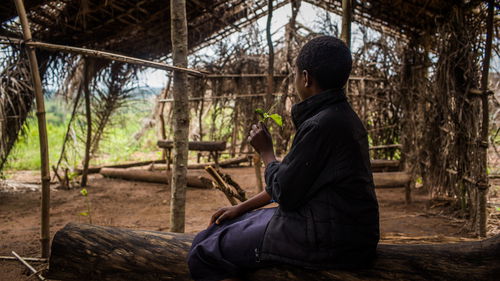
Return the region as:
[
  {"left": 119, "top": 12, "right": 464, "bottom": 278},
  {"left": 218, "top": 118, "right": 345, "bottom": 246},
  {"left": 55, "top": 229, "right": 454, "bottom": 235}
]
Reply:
[{"left": 157, "top": 140, "right": 226, "bottom": 170}]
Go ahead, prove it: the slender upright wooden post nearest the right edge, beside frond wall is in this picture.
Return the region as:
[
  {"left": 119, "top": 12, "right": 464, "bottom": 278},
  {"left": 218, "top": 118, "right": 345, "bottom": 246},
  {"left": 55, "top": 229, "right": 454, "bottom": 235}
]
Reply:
[{"left": 477, "top": 0, "right": 495, "bottom": 237}]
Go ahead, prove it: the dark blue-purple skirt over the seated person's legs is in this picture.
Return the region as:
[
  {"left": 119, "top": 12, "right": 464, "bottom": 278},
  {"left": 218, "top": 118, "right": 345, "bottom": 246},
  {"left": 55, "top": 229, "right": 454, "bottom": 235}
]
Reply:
[{"left": 188, "top": 208, "right": 276, "bottom": 281}]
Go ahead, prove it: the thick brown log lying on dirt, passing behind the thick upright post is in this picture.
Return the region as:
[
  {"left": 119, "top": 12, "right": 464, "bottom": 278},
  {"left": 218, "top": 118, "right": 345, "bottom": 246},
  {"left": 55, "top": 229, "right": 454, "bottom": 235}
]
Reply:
[{"left": 101, "top": 168, "right": 212, "bottom": 188}]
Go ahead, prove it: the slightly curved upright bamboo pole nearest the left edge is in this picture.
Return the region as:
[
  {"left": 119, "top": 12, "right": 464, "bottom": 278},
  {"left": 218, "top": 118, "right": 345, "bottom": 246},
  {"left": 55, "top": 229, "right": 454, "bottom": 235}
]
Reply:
[{"left": 15, "top": 0, "right": 50, "bottom": 258}]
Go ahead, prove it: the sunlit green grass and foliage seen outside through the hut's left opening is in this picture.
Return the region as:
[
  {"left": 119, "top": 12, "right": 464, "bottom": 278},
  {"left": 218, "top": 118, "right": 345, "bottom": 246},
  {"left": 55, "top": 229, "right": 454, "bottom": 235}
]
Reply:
[{"left": 5, "top": 98, "right": 161, "bottom": 171}]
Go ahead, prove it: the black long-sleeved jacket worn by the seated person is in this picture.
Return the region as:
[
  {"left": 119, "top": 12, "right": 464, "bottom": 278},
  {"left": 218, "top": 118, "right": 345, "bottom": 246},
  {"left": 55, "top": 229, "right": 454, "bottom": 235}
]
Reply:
[{"left": 257, "top": 90, "right": 379, "bottom": 268}]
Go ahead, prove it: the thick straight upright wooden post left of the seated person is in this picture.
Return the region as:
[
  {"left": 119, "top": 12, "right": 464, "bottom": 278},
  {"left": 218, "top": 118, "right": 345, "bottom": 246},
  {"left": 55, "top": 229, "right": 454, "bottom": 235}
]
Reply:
[{"left": 170, "top": 0, "right": 189, "bottom": 232}]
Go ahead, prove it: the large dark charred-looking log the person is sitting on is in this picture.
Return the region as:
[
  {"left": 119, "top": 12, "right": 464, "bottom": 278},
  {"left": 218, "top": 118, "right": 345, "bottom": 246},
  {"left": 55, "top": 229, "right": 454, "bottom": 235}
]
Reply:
[{"left": 45, "top": 223, "right": 500, "bottom": 281}]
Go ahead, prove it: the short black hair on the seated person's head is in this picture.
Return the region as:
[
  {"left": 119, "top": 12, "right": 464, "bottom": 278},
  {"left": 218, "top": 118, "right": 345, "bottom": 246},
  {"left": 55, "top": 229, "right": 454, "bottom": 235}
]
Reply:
[{"left": 295, "top": 36, "right": 352, "bottom": 90}]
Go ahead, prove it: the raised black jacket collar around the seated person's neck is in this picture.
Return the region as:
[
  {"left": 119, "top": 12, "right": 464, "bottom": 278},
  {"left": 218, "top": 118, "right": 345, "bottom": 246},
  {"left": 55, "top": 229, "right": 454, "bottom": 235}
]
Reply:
[{"left": 292, "top": 89, "right": 347, "bottom": 129}]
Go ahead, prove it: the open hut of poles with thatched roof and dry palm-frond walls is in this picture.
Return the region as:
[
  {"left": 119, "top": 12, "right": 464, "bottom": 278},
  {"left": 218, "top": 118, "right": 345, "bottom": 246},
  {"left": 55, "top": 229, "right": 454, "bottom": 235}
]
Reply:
[{"left": 0, "top": 0, "right": 499, "bottom": 276}]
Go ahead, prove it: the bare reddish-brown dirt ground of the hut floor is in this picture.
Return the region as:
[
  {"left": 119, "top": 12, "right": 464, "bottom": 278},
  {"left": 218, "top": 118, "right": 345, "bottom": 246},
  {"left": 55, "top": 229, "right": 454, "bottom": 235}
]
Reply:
[{"left": 0, "top": 167, "right": 498, "bottom": 280}]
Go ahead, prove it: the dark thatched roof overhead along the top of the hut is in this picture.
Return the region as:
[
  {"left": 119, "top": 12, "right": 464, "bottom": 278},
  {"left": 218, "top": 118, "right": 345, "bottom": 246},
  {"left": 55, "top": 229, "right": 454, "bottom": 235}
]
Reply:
[{"left": 0, "top": 0, "right": 484, "bottom": 59}]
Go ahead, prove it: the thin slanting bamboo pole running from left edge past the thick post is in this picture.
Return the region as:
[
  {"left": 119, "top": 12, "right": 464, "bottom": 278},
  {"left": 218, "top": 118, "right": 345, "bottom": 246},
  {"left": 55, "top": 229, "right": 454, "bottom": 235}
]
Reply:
[{"left": 0, "top": 35, "right": 206, "bottom": 76}]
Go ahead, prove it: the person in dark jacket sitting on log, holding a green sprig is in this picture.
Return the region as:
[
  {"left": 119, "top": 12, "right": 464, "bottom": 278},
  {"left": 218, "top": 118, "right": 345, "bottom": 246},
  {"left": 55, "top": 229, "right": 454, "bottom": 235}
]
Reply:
[{"left": 188, "top": 36, "right": 379, "bottom": 280}]
